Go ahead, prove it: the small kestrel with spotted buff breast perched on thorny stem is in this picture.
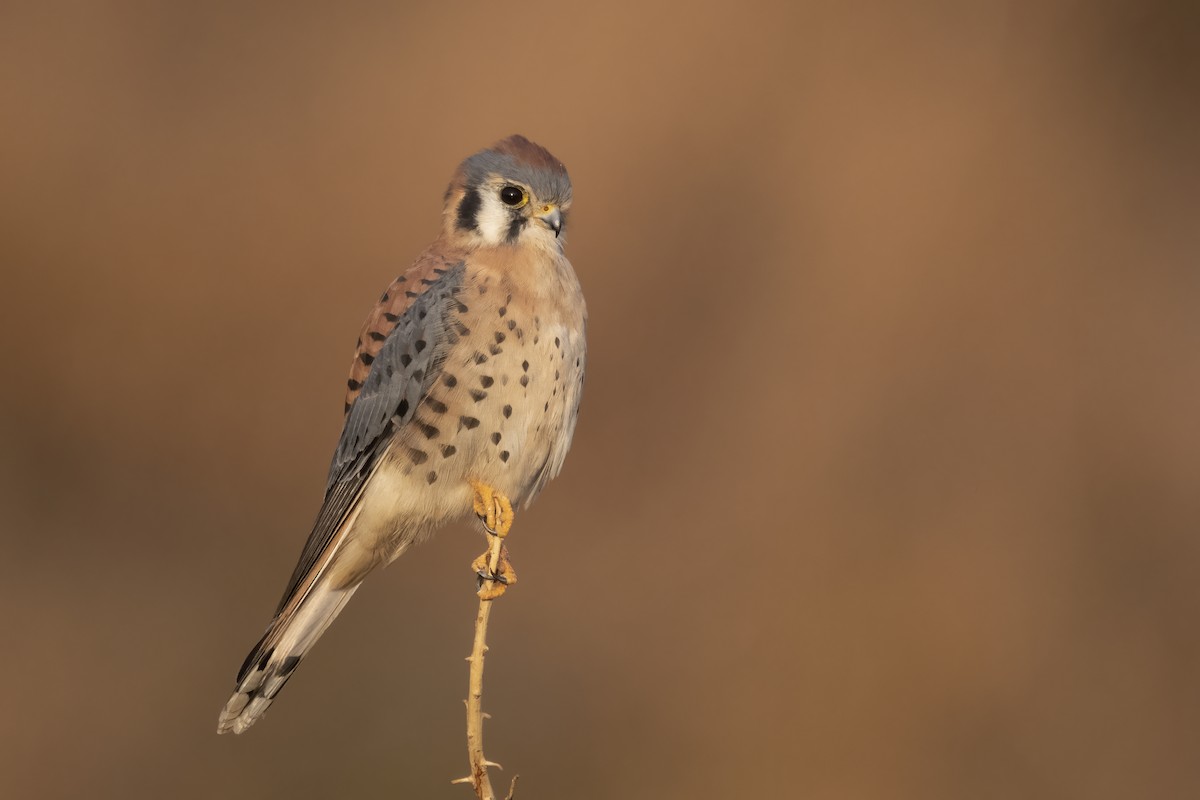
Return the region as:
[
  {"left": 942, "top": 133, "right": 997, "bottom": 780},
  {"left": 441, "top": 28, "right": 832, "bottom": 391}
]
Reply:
[{"left": 217, "top": 134, "right": 587, "bottom": 734}]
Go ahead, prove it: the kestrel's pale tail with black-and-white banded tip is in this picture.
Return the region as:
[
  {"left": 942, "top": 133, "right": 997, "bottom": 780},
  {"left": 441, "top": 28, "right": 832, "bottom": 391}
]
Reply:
[{"left": 217, "top": 577, "right": 358, "bottom": 733}]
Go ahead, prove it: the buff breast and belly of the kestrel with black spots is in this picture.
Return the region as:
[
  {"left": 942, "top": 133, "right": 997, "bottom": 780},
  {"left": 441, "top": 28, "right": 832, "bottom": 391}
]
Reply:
[{"left": 384, "top": 250, "right": 586, "bottom": 513}]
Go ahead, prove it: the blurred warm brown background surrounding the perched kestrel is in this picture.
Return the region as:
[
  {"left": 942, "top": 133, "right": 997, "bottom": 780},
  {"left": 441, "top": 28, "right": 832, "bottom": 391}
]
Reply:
[{"left": 0, "top": 0, "right": 1200, "bottom": 799}]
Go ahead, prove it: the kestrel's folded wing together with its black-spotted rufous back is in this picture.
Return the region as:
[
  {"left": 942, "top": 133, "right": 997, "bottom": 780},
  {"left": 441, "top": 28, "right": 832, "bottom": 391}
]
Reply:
[{"left": 276, "top": 253, "right": 467, "bottom": 614}]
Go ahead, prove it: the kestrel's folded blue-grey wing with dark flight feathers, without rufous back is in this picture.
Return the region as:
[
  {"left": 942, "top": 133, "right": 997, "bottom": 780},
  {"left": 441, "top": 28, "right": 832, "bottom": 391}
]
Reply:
[{"left": 276, "top": 261, "right": 467, "bottom": 613}]
